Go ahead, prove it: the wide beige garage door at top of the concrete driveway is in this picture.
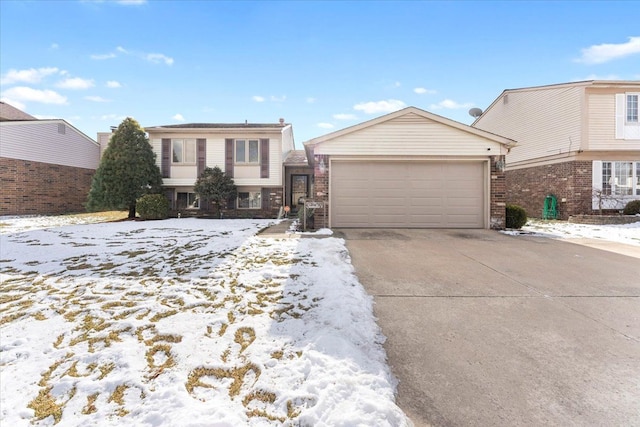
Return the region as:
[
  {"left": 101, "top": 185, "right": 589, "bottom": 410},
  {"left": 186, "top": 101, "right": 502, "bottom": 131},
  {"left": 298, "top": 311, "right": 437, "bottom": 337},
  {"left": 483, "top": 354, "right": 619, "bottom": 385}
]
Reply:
[{"left": 331, "top": 161, "right": 485, "bottom": 228}]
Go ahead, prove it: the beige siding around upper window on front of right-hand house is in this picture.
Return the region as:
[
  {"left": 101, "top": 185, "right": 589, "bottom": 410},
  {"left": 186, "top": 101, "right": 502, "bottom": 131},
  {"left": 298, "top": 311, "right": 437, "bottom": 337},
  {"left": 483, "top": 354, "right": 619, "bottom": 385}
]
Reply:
[{"left": 586, "top": 92, "right": 640, "bottom": 151}]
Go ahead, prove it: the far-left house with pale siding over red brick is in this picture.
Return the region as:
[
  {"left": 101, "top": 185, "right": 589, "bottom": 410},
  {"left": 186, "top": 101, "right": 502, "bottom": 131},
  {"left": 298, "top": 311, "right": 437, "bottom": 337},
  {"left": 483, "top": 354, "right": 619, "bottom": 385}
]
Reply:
[{"left": 0, "top": 102, "right": 100, "bottom": 215}]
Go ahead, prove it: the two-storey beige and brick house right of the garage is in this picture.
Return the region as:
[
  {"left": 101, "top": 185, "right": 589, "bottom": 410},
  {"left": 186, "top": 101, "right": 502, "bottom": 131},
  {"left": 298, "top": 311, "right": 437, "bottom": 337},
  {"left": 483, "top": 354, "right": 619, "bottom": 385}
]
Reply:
[{"left": 472, "top": 80, "right": 640, "bottom": 219}]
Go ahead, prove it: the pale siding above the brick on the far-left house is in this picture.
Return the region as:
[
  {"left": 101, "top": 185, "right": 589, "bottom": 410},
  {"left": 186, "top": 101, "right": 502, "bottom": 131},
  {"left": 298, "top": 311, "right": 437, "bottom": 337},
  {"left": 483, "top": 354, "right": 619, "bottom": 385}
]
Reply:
[{"left": 0, "top": 120, "right": 100, "bottom": 169}]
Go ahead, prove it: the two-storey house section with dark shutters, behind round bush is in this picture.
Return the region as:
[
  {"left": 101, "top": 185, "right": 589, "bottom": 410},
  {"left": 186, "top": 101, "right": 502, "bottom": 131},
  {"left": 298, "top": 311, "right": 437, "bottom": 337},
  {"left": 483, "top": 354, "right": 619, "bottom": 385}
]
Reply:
[{"left": 145, "top": 119, "right": 294, "bottom": 217}]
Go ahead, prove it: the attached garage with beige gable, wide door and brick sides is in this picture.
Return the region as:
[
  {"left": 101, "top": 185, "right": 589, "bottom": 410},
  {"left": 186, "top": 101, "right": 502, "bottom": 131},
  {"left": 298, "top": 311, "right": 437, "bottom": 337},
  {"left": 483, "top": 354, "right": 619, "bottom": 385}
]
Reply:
[{"left": 305, "top": 107, "right": 515, "bottom": 229}]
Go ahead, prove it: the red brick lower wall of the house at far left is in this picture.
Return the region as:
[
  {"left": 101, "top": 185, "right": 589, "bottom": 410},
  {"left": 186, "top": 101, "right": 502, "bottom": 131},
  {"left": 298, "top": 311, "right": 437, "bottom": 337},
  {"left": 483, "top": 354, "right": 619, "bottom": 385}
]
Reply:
[{"left": 0, "top": 157, "right": 95, "bottom": 215}]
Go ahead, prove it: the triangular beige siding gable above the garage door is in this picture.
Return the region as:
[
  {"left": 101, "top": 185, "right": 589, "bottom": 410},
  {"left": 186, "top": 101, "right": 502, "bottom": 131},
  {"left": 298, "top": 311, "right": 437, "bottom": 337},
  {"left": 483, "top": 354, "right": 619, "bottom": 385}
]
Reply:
[{"left": 314, "top": 113, "right": 502, "bottom": 156}]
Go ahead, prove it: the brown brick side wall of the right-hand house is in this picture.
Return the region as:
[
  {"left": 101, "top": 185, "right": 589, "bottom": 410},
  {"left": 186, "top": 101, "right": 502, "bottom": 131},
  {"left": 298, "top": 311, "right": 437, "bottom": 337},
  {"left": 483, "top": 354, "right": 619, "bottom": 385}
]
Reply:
[{"left": 506, "top": 161, "right": 593, "bottom": 219}]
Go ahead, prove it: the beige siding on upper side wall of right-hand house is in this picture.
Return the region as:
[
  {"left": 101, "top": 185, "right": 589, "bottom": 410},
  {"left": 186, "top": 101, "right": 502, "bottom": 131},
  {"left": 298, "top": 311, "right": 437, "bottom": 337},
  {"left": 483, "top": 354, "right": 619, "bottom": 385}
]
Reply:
[{"left": 474, "top": 86, "right": 584, "bottom": 164}]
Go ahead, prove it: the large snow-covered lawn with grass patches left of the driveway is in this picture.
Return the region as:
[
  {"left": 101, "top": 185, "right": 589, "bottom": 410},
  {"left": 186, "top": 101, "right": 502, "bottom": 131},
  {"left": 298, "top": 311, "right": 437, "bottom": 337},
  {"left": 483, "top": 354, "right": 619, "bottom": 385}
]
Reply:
[{"left": 0, "top": 217, "right": 410, "bottom": 427}]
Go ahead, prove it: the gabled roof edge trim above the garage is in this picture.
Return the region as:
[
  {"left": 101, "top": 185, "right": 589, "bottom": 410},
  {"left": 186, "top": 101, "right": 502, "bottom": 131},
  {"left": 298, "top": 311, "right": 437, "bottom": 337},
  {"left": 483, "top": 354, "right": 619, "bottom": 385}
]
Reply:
[{"left": 304, "top": 107, "right": 516, "bottom": 163}]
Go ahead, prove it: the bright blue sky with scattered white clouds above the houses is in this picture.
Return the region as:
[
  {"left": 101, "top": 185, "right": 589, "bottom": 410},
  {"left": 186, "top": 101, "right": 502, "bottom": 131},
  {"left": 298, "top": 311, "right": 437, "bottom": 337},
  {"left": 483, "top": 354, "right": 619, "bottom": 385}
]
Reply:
[{"left": 0, "top": 0, "right": 640, "bottom": 148}]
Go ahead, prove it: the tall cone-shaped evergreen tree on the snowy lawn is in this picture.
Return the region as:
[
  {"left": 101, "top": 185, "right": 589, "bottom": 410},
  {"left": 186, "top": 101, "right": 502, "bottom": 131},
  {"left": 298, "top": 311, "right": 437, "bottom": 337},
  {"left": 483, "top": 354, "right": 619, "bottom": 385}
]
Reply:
[{"left": 86, "top": 117, "right": 162, "bottom": 218}]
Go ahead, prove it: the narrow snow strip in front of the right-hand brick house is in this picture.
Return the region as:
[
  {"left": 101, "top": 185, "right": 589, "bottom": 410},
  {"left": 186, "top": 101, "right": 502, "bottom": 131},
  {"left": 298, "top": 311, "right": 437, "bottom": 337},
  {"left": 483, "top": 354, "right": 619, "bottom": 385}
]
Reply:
[{"left": 503, "top": 219, "right": 640, "bottom": 246}]
